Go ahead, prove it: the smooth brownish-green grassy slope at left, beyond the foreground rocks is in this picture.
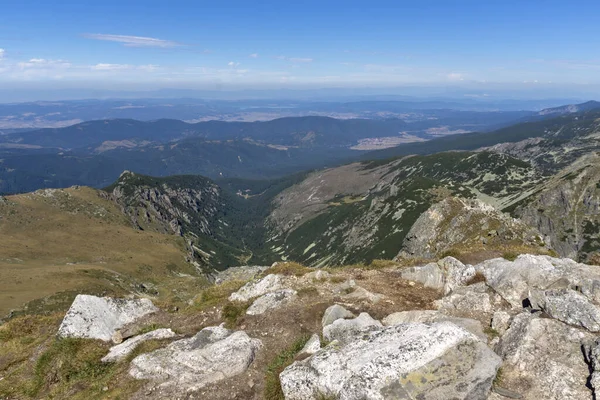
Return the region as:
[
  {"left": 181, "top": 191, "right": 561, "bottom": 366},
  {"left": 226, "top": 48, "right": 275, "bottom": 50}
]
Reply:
[{"left": 0, "top": 188, "right": 200, "bottom": 316}]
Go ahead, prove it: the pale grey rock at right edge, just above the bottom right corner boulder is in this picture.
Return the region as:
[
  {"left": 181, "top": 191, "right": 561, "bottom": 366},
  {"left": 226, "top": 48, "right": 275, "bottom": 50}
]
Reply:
[{"left": 529, "top": 289, "right": 600, "bottom": 332}]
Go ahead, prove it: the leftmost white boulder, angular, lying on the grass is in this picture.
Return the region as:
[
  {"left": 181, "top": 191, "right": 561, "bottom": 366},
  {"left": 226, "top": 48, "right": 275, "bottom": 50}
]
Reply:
[{"left": 58, "top": 294, "right": 158, "bottom": 341}]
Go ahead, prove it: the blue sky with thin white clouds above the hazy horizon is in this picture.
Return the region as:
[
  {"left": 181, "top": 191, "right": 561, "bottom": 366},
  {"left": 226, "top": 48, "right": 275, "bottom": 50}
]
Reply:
[{"left": 0, "top": 0, "right": 600, "bottom": 89}]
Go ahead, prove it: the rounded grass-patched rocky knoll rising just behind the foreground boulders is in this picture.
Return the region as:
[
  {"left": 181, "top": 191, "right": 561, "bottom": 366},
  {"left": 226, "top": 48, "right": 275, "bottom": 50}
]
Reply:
[{"left": 398, "top": 198, "right": 542, "bottom": 258}]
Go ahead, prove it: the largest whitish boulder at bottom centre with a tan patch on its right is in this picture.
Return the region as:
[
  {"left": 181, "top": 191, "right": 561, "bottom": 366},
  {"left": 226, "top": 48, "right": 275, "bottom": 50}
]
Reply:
[{"left": 280, "top": 322, "right": 501, "bottom": 400}]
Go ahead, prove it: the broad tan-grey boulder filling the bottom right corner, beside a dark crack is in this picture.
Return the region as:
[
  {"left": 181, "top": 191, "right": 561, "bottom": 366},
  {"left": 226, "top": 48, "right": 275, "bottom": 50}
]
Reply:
[{"left": 496, "top": 312, "right": 594, "bottom": 400}]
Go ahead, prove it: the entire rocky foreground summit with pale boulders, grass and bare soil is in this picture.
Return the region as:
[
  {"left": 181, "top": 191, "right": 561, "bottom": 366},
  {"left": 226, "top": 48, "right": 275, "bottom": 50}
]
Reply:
[{"left": 0, "top": 254, "right": 600, "bottom": 400}]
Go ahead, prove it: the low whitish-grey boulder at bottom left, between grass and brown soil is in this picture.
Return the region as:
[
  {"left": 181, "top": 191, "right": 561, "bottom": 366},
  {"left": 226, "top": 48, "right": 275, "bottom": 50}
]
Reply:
[{"left": 129, "top": 327, "right": 261, "bottom": 390}]
